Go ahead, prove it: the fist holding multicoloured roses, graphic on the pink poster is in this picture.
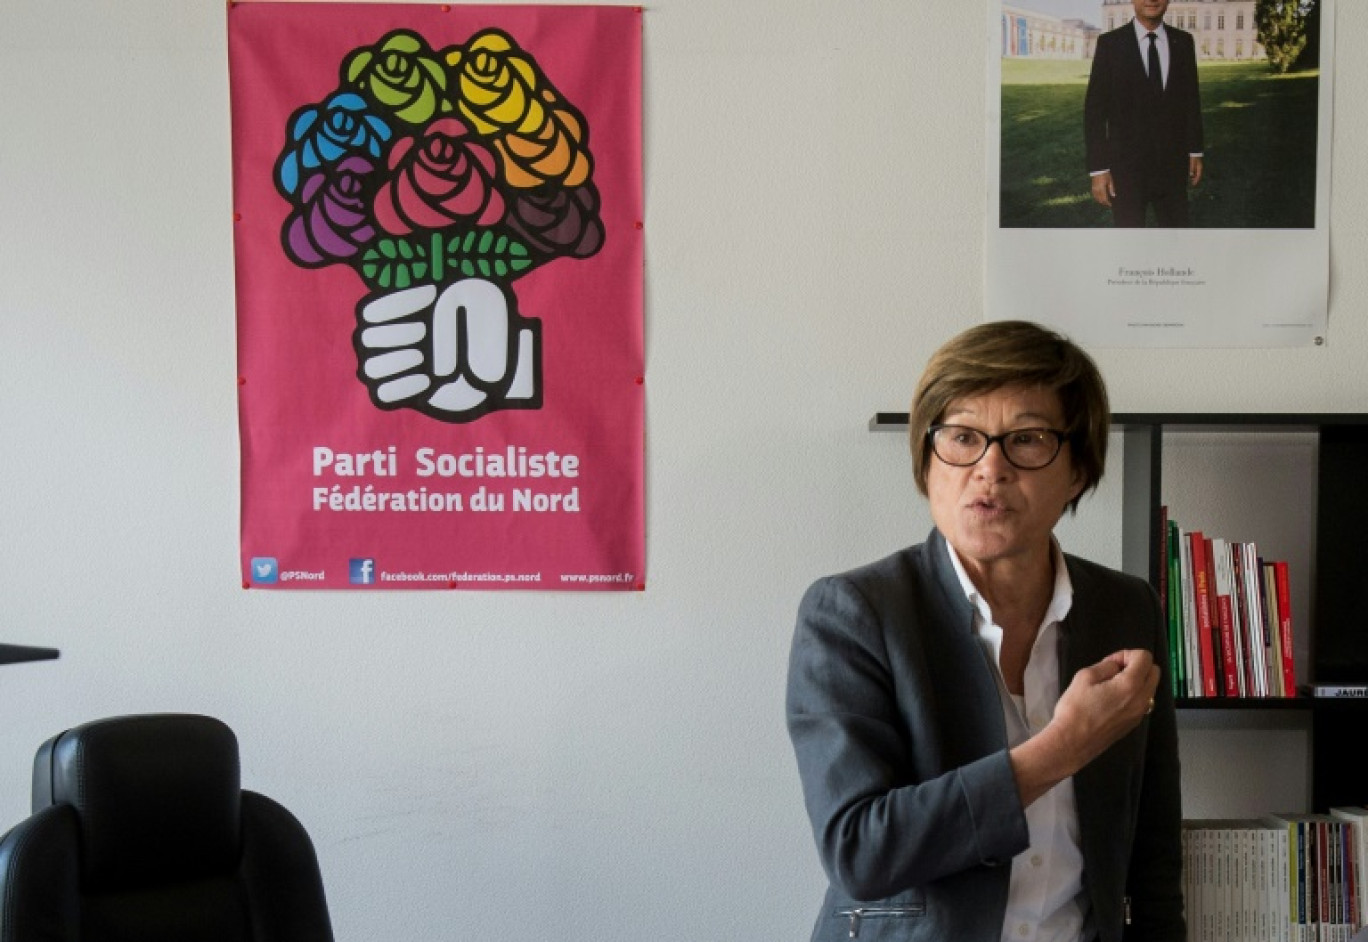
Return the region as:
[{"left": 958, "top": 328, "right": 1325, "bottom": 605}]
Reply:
[{"left": 275, "top": 29, "right": 603, "bottom": 422}]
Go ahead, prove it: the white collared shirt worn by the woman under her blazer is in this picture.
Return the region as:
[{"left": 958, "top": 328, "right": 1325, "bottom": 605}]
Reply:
[{"left": 945, "top": 540, "right": 1093, "bottom": 942}]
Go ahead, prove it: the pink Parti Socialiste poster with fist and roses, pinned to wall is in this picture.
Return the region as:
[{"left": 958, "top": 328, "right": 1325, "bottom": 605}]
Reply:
[{"left": 227, "top": 3, "right": 644, "bottom": 591}]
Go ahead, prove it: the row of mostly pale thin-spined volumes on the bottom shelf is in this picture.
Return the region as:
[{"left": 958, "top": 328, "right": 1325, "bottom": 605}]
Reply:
[{"left": 1183, "top": 807, "right": 1368, "bottom": 942}]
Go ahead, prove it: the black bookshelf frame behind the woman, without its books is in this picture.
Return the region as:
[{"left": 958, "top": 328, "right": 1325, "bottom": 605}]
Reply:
[{"left": 869, "top": 412, "right": 1368, "bottom": 811}]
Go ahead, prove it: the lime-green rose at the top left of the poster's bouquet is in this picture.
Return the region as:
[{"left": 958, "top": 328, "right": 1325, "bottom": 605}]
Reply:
[{"left": 342, "top": 30, "right": 451, "bottom": 124}]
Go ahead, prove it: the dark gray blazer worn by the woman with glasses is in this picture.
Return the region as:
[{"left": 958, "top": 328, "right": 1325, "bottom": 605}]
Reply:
[{"left": 788, "top": 530, "right": 1186, "bottom": 942}]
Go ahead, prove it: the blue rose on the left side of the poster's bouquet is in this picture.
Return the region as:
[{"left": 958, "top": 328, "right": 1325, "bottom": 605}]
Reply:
[{"left": 275, "top": 92, "right": 394, "bottom": 197}]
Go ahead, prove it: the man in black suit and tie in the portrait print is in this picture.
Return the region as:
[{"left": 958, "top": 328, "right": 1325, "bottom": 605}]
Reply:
[{"left": 1083, "top": 0, "right": 1202, "bottom": 228}]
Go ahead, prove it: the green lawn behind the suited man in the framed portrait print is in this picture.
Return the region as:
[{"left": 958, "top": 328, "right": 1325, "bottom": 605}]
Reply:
[{"left": 1000, "top": 59, "right": 1319, "bottom": 228}]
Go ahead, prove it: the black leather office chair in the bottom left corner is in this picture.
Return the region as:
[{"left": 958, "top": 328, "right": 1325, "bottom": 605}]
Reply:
[{"left": 0, "top": 714, "right": 332, "bottom": 942}]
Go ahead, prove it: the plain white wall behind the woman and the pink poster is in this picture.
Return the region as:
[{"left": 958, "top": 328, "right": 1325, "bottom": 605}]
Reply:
[{"left": 0, "top": 0, "right": 1368, "bottom": 942}]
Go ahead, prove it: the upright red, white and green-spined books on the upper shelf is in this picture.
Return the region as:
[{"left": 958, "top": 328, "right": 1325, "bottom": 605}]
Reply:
[{"left": 1159, "top": 507, "right": 1297, "bottom": 697}]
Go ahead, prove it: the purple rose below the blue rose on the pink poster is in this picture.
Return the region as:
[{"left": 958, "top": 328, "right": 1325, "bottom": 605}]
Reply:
[{"left": 283, "top": 156, "right": 375, "bottom": 268}]
